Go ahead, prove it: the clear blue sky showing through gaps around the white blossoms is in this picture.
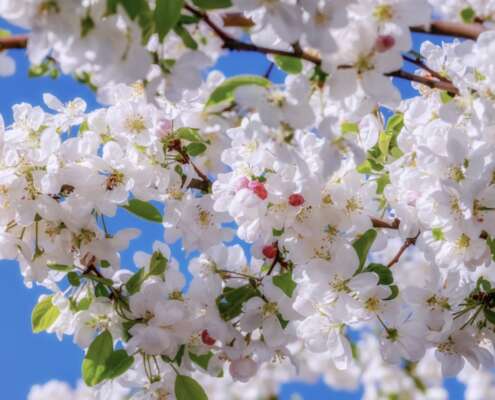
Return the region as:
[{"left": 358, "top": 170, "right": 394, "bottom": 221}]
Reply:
[{"left": 0, "top": 19, "right": 463, "bottom": 400}]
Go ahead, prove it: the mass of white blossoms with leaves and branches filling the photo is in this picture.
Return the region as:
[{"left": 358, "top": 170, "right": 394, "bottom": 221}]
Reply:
[{"left": 0, "top": 0, "right": 495, "bottom": 400}]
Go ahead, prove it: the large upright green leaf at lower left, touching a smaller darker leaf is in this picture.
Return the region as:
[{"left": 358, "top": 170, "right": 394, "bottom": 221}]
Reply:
[{"left": 81, "top": 331, "right": 113, "bottom": 386}]
